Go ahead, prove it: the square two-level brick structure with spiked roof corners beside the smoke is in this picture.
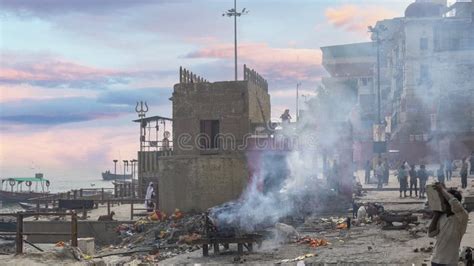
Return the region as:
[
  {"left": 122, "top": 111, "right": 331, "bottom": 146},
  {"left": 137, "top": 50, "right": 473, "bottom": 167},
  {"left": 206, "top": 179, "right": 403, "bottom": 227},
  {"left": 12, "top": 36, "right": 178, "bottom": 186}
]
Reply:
[{"left": 157, "top": 67, "right": 270, "bottom": 212}]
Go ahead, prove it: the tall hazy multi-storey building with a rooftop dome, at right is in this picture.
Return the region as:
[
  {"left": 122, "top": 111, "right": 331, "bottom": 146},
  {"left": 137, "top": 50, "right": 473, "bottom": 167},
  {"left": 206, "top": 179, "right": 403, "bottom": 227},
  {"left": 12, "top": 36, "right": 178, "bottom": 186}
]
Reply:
[{"left": 322, "top": 0, "right": 474, "bottom": 166}]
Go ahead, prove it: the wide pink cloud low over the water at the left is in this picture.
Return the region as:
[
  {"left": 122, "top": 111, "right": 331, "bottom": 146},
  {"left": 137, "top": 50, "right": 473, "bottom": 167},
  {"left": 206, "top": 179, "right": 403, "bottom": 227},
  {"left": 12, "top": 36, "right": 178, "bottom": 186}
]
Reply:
[{"left": 0, "top": 124, "right": 138, "bottom": 179}]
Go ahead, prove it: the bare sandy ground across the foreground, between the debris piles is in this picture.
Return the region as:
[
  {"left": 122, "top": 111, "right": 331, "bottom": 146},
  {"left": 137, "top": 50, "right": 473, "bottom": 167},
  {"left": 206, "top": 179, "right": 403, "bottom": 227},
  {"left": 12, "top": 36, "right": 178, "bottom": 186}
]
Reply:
[{"left": 4, "top": 172, "right": 474, "bottom": 265}]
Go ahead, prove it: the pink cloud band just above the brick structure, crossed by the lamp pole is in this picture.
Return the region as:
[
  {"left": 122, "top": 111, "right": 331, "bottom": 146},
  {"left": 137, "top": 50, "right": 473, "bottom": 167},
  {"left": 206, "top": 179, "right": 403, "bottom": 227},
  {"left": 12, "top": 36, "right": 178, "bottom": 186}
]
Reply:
[{"left": 187, "top": 43, "right": 322, "bottom": 80}]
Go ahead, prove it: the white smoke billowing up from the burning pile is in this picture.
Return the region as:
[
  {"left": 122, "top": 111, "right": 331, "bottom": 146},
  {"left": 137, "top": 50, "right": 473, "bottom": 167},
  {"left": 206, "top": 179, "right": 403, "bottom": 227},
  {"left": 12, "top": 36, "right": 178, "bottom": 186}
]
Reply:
[{"left": 211, "top": 84, "right": 353, "bottom": 231}]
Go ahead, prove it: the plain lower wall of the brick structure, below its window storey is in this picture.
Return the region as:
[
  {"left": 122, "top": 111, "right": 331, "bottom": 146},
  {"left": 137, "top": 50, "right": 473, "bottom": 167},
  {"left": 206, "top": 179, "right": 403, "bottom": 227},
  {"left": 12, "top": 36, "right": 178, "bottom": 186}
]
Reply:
[{"left": 158, "top": 154, "right": 248, "bottom": 213}]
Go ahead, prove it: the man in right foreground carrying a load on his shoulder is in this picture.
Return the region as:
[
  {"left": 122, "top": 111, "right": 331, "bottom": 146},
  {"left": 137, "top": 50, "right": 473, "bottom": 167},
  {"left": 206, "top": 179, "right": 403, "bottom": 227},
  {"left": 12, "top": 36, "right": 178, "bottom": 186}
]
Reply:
[{"left": 428, "top": 184, "right": 469, "bottom": 265}]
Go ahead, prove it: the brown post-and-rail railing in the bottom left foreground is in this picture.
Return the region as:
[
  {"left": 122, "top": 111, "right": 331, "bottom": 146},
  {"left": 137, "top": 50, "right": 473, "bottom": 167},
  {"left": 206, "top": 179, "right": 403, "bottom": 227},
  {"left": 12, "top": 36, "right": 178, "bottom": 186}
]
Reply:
[{"left": 0, "top": 211, "right": 78, "bottom": 255}]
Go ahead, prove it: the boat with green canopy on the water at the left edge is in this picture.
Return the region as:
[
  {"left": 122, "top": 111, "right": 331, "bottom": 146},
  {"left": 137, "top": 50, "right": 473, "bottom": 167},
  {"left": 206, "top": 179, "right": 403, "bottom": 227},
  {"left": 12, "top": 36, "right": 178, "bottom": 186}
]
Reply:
[{"left": 0, "top": 173, "right": 50, "bottom": 203}]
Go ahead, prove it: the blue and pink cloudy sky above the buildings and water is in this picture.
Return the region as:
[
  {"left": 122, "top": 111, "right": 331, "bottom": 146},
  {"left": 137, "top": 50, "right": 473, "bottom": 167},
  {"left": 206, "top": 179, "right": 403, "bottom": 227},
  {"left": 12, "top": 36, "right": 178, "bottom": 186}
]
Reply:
[{"left": 0, "top": 0, "right": 412, "bottom": 180}]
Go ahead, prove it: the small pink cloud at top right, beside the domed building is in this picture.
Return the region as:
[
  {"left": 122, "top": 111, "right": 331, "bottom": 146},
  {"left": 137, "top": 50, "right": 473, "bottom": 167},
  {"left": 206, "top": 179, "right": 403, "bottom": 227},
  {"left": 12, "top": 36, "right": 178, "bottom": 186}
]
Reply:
[{"left": 325, "top": 5, "right": 396, "bottom": 34}]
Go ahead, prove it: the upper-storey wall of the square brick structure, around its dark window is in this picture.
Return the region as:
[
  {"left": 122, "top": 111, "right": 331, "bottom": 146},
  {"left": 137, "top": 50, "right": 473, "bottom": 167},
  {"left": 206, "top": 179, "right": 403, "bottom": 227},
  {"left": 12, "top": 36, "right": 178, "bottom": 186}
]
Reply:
[{"left": 173, "top": 80, "right": 270, "bottom": 155}]
